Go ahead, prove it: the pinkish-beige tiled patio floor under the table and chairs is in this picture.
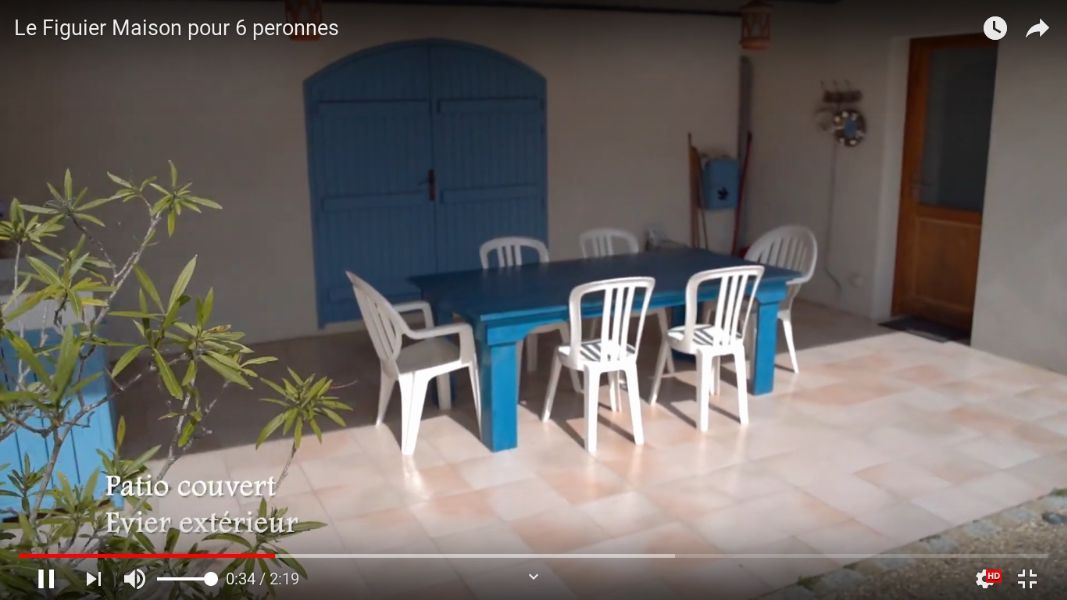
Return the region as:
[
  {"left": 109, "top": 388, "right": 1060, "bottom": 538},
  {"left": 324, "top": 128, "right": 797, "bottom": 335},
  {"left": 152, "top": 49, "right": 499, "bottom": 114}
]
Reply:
[{"left": 120, "top": 303, "right": 1067, "bottom": 598}]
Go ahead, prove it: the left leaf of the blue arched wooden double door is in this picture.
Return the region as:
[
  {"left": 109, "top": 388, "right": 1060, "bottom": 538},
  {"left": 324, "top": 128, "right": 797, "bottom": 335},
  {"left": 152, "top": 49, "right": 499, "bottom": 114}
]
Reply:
[{"left": 305, "top": 46, "right": 436, "bottom": 326}]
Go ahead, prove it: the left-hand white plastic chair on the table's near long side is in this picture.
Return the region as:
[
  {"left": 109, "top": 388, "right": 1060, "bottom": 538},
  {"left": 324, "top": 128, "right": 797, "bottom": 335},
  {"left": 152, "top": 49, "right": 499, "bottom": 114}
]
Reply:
[{"left": 541, "top": 278, "right": 655, "bottom": 454}]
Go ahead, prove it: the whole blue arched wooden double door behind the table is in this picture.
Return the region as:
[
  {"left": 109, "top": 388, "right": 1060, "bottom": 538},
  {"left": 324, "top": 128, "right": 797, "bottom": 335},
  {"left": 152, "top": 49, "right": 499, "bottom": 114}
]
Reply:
[{"left": 304, "top": 40, "right": 546, "bottom": 326}]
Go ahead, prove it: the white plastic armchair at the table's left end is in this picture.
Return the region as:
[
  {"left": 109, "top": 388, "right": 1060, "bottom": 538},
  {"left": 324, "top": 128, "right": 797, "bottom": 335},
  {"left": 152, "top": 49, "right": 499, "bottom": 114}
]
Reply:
[{"left": 346, "top": 271, "right": 481, "bottom": 455}]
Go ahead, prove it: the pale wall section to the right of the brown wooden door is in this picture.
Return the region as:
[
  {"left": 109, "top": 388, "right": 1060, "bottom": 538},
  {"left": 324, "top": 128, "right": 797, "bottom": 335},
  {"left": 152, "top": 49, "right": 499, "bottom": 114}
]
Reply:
[{"left": 973, "top": 16, "right": 1067, "bottom": 372}]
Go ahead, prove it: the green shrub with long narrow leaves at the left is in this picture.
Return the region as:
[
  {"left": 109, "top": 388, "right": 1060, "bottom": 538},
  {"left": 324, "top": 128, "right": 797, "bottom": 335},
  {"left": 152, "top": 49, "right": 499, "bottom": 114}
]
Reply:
[{"left": 0, "top": 163, "right": 348, "bottom": 598}]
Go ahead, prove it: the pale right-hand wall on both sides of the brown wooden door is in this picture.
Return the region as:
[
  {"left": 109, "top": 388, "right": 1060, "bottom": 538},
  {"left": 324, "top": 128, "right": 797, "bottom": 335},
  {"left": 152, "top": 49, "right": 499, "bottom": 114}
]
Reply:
[{"left": 745, "top": 0, "right": 1067, "bottom": 370}]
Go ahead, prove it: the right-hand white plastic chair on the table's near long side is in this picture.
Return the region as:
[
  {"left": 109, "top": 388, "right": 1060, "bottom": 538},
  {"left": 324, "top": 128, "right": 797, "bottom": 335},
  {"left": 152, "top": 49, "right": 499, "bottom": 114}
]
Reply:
[{"left": 649, "top": 266, "right": 763, "bottom": 431}]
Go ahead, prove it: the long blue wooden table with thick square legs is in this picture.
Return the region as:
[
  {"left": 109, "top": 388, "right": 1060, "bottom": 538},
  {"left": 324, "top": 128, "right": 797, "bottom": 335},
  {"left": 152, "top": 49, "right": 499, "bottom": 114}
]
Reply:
[{"left": 411, "top": 249, "right": 798, "bottom": 452}]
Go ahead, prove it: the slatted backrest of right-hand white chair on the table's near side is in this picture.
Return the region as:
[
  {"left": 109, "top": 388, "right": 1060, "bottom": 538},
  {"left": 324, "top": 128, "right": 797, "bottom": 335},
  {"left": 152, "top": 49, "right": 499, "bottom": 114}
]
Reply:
[{"left": 682, "top": 265, "right": 763, "bottom": 346}]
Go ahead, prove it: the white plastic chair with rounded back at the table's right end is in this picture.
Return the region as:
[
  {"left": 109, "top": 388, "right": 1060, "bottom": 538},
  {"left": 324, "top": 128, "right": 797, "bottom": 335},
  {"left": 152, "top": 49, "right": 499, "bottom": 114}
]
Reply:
[{"left": 702, "top": 225, "right": 818, "bottom": 373}]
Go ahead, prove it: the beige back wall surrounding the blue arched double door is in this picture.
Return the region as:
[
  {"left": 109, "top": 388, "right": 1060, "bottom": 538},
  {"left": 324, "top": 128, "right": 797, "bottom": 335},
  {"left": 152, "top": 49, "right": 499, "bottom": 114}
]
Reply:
[{"left": 0, "top": 2, "right": 738, "bottom": 340}]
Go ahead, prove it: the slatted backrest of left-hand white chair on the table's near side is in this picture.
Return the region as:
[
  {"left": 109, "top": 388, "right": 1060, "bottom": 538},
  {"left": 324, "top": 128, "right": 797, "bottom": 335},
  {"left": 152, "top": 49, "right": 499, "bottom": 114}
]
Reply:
[{"left": 569, "top": 278, "right": 656, "bottom": 363}]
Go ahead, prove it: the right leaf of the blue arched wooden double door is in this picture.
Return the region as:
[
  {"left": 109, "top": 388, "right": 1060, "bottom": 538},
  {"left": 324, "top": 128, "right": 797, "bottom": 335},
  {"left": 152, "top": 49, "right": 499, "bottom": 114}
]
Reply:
[{"left": 430, "top": 43, "right": 547, "bottom": 271}]
